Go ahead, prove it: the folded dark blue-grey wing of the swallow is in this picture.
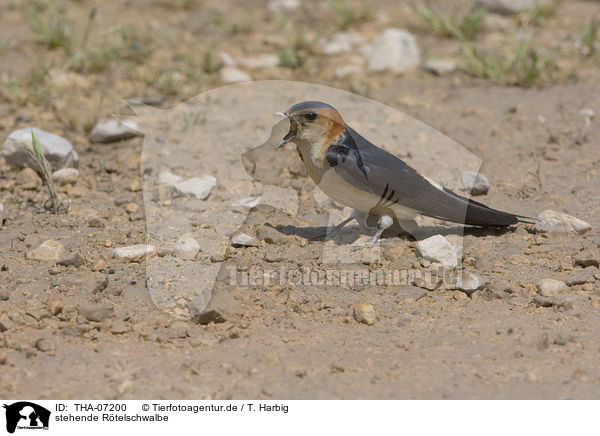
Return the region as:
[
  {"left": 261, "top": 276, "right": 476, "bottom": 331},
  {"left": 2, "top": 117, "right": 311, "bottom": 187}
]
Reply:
[{"left": 327, "top": 127, "right": 519, "bottom": 226}]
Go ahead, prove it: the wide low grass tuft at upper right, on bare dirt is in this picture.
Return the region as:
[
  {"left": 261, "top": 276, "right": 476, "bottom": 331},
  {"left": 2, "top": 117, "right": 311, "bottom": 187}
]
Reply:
[{"left": 463, "top": 41, "right": 552, "bottom": 88}]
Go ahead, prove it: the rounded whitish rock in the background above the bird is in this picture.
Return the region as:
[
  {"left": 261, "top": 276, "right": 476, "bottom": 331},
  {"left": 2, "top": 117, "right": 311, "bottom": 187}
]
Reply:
[{"left": 367, "top": 28, "right": 421, "bottom": 73}]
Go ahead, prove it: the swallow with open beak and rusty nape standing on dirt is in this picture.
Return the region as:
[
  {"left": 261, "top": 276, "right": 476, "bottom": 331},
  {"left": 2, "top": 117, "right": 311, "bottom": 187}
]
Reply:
[{"left": 276, "top": 101, "right": 531, "bottom": 245}]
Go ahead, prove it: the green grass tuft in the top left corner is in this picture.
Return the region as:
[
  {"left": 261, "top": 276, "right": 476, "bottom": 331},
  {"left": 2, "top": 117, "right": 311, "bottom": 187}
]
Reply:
[{"left": 27, "top": 2, "right": 75, "bottom": 52}]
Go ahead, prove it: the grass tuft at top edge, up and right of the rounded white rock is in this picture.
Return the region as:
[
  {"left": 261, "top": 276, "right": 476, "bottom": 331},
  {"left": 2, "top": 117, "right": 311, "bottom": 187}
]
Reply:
[{"left": 415, "top": 6, "right": 486, "bottom": 39}]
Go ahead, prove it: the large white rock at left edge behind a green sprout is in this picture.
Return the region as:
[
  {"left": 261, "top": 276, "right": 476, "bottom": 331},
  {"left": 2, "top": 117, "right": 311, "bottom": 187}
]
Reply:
[{"left": 2, "top": 127, "right": 79, "bottom": 171}]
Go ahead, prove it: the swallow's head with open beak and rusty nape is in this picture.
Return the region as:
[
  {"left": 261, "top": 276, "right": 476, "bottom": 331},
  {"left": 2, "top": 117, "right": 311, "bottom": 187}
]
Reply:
[{"left": 279, "top": 101, "right": 346, "bottom": 147}]
